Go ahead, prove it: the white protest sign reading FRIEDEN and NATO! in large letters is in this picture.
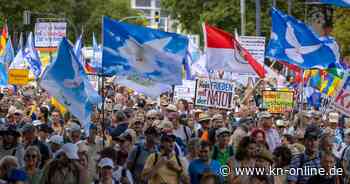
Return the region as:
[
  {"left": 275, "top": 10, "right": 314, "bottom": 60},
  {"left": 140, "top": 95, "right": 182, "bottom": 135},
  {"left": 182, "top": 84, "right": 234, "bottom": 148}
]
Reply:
[{"left": 195, "top": 79, "right": 235, "bottom": 109}]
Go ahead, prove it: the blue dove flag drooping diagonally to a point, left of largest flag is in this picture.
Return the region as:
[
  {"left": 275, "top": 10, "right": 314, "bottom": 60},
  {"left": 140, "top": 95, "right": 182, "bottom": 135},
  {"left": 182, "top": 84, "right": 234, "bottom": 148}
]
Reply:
[{"left": 39, "top": 38, "right": 101, "bottom": 126}]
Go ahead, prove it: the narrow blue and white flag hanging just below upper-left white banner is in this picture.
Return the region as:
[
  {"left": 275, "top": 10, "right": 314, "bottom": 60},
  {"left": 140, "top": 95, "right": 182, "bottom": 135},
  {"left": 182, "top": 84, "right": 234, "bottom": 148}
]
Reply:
[{"left": 22, "top": 32, "right": 41, "bottom": 79}]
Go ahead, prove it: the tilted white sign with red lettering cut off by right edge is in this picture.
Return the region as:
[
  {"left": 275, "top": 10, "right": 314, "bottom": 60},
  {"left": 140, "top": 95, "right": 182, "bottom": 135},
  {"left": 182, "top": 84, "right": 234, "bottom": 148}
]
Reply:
[{"left": 332, "top": 75, "right": 350, "bottom": 116}]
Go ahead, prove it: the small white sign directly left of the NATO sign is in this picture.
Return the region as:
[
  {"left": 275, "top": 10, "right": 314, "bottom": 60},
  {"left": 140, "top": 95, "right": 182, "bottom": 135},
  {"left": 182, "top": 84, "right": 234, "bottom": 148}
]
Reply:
[{"left": 174, "top": 80, "right": 196, "bottom": 102}]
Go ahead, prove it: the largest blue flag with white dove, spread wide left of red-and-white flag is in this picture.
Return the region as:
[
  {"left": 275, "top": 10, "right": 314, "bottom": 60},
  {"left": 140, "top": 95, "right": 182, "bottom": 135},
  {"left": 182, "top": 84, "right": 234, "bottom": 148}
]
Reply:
[{"left": 102, "top": 17, "right": 188, "bottom": 85}]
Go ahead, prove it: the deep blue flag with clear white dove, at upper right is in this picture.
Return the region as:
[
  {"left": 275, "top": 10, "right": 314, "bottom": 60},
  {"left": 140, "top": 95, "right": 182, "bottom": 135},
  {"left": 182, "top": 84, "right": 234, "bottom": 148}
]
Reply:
[{"left": 266, "top": 8, "right": 339, "bottom": 69}]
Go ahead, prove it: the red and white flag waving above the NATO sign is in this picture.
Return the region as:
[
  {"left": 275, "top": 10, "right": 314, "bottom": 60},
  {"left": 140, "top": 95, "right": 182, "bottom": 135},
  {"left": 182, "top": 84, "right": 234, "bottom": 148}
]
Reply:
[{"left": 204, "top": 24, "right": 266, "bottom": 78}]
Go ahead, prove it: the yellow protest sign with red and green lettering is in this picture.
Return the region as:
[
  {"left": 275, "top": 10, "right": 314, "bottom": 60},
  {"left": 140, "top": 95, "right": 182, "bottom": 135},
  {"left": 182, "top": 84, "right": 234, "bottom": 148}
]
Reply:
[{"left": 263, "top": 90, "right": 294, "bottom": 113}]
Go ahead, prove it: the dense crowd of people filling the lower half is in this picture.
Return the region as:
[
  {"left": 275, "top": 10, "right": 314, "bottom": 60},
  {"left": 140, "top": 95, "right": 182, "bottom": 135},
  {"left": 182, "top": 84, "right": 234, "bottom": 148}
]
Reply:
[{"left": 0, "top": 85, "right": 350, "bottom": 184}]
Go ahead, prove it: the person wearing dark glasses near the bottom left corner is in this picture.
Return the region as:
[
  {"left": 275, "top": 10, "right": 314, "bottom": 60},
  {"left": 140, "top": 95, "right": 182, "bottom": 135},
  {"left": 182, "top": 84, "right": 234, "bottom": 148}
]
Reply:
[{"left": 23, "top": 146, "right": 42, "bottom": 184}]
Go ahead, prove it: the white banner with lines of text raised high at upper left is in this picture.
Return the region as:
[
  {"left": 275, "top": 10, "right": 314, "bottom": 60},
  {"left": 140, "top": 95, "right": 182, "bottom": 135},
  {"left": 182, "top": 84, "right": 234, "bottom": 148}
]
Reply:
[{"left": 34, "top": 22, "right": 67, "bottom": 48}]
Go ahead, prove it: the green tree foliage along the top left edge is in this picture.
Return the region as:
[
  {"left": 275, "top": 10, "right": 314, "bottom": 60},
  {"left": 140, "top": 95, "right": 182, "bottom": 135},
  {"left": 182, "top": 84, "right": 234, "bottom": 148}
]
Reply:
[{"left": 0, "top": 0, "right": 144, "bottom": 44}]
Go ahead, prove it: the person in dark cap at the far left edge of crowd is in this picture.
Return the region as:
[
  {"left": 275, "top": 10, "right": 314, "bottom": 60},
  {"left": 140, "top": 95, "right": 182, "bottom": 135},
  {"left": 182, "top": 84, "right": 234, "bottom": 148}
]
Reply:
[{"left": 0, "top": 127, "right": 24, "bottom": 167}]
